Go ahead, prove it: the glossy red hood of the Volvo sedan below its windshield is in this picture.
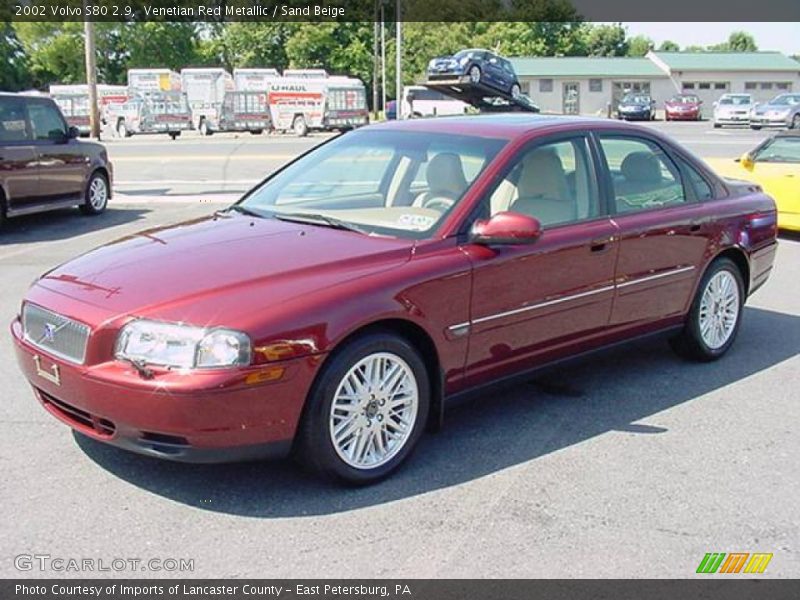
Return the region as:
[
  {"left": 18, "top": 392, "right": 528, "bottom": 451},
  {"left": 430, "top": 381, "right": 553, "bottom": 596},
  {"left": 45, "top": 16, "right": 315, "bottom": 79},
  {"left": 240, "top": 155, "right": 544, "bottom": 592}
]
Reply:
[{"left": 29, "top": 213, "right": 414, "bottom": 322}]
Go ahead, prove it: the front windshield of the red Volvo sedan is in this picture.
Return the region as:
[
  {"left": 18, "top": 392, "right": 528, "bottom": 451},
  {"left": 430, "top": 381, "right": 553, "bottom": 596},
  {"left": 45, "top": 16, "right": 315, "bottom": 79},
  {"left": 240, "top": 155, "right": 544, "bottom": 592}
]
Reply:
[{"left": 238, "top": 131, "right": 506, "bottom": 238}]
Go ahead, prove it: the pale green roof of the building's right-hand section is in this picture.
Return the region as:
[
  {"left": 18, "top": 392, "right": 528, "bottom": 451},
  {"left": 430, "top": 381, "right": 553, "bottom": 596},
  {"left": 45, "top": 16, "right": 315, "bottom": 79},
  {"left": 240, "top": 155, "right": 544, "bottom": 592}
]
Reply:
[{"left": 650, "top": 52, "right": 800, "bottom": 72}]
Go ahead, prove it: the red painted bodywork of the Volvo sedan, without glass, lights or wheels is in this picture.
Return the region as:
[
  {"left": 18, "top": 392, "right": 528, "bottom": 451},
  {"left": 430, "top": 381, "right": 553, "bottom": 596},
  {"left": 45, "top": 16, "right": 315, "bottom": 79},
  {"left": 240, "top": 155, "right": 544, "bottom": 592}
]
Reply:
[{"left": 12, "top": 116, "right": 776, "bottom": 458}]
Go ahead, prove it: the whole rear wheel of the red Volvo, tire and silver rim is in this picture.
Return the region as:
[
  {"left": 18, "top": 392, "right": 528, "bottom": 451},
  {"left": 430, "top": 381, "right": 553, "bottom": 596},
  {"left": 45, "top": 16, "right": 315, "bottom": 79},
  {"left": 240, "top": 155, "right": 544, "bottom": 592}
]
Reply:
[{"left": 671, "top": 258, "right": 745, "bottom": 361}]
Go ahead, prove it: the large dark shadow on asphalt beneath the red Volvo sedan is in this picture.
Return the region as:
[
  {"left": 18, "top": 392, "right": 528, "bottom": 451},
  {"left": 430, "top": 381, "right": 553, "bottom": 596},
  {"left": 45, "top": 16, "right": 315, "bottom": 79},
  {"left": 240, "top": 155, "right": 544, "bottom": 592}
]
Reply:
[{"left": 75, "top": 308, "right": 800, "bottom": 518}]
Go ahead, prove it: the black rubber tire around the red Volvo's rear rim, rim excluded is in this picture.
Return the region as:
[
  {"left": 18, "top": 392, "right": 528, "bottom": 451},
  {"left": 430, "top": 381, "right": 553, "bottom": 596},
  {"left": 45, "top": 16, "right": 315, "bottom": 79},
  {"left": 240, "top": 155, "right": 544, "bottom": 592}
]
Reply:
[{"left": 670, "top": 258, "right": 745, "bottom": 362}]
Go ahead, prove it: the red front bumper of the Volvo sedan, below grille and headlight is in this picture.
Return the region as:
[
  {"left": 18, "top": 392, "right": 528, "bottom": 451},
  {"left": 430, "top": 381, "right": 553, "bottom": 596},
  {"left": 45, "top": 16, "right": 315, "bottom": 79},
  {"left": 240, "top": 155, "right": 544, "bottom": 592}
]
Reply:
[{"left": 11, "top": 319, "right": 321, "bottom": 462}]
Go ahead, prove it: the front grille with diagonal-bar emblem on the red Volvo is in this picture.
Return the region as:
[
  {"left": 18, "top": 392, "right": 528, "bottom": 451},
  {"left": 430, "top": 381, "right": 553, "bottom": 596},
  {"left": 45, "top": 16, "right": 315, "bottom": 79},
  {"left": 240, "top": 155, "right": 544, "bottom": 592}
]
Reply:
[{"left": 22, "top": 303, "right": 89, "bottom": 364}]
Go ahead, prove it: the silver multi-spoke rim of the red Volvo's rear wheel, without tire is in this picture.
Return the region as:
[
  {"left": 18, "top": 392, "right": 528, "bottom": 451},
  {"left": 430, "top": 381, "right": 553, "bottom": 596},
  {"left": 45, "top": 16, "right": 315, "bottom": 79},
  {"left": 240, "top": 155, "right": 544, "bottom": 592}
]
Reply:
[{"left": 698, "top": 270, "right": 741, "bottom": 350}]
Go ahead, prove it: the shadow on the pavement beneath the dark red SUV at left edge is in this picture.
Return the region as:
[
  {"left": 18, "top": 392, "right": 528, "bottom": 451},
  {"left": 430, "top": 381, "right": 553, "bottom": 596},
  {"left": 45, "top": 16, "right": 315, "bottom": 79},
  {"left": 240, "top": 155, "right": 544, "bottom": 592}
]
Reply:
[{"left": 0, "top": 207, "right": 150, "bottom": 247}]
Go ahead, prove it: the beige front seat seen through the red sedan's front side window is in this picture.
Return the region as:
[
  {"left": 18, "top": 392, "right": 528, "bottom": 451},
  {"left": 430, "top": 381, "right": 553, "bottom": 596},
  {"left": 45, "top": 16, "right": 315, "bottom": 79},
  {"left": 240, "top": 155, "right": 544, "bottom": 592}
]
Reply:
[{"left": 509, "top": 149, "right": 577, "bottom": 225}]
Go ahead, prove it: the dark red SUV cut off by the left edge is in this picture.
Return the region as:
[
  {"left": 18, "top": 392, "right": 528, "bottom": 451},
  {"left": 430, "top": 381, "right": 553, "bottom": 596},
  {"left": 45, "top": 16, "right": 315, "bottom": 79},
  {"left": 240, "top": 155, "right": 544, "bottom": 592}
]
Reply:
[{"left": 0, "top": 93, "right": 112, "bottom": 223}]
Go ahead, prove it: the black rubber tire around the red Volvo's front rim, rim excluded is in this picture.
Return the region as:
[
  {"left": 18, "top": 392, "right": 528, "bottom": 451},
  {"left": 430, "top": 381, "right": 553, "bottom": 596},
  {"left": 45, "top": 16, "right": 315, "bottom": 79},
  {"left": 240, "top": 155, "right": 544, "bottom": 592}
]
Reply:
[{"left": 294, "top": 333, "right": 430, "bottom": 485}]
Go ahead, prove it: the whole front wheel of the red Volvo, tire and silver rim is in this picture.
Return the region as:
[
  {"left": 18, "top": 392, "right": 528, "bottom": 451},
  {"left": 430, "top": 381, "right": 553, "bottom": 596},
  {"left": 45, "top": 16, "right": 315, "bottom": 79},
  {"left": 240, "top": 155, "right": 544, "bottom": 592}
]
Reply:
[{"left": 297, "top": 333, "right": 430, "bottom": 484}]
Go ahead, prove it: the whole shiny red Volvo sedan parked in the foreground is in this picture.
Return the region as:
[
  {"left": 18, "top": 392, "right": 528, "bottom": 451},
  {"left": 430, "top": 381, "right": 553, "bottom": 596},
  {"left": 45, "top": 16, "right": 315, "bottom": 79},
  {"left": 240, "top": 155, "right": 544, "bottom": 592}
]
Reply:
[{"left": 11, "top": 115, "right": 776, "bottom": 483}]
